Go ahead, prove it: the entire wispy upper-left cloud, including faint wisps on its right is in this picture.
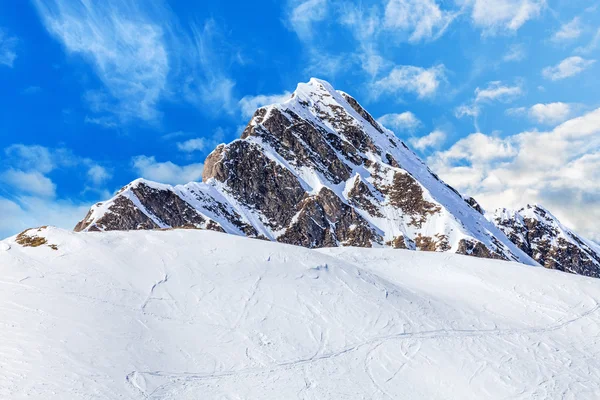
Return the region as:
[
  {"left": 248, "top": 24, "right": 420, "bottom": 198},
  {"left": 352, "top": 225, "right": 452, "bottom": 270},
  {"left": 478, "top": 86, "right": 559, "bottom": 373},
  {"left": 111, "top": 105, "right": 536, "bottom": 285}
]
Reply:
[{"left": 33, "top": 0, "right": 235, "bottom": 126}]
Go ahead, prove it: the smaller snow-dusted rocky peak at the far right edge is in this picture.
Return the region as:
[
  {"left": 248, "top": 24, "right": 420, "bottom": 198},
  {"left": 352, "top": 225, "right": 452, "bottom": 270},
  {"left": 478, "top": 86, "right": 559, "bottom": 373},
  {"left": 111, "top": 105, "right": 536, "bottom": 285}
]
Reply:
[{"left": 489, "top": 205, "right": 600, "bottom": 278}]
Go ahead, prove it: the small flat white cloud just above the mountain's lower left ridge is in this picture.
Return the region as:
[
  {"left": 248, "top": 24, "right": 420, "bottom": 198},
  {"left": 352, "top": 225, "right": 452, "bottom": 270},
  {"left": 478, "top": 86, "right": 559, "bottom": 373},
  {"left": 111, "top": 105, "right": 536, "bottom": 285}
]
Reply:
[{"left": 132, "top": 155, "right": 204, "bottom": 185}]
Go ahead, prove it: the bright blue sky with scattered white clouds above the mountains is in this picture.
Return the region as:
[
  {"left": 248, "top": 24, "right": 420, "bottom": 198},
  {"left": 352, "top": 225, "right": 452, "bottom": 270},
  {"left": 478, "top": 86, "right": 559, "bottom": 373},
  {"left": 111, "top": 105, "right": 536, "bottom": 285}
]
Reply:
[{"left": 0, "top": 0, "right": 600, "bottom": 240}]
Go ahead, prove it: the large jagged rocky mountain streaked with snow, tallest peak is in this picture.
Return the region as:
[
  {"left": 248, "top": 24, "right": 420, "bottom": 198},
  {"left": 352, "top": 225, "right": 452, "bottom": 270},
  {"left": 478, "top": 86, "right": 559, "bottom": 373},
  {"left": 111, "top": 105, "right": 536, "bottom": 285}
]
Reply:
[{"left": 76, "top": 79, "right": 535, "bottom": 264}]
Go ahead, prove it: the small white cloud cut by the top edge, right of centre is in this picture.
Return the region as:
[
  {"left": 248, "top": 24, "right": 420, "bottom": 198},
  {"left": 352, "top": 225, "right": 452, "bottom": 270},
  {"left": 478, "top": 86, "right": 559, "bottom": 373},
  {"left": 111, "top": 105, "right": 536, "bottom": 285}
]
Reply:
[{"left": 462, "top": 0, "right": 546, "bottom": 34}]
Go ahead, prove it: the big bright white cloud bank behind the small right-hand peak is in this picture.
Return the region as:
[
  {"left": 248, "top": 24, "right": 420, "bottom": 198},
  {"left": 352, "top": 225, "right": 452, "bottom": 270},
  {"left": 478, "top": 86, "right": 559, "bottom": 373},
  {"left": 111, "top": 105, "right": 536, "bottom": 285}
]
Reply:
[{"left": 428, "top": 109, "right": 600, "bottom": 239}]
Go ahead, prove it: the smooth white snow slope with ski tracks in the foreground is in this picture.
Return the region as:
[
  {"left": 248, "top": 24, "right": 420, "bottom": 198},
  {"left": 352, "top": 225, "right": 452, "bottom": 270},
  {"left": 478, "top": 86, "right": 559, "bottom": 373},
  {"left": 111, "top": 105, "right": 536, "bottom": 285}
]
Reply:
[{"left": 0, "top": 228, "right": 600, "bottom": 399}]
